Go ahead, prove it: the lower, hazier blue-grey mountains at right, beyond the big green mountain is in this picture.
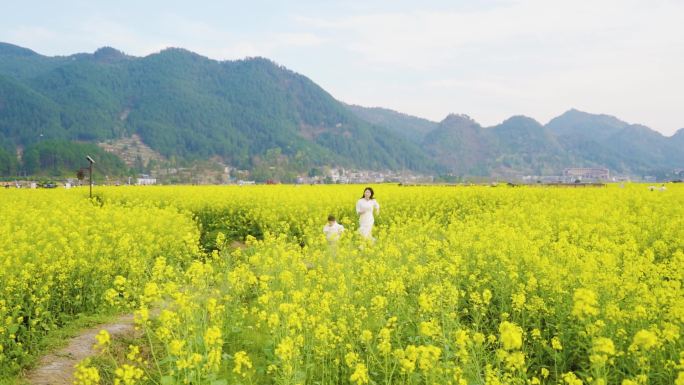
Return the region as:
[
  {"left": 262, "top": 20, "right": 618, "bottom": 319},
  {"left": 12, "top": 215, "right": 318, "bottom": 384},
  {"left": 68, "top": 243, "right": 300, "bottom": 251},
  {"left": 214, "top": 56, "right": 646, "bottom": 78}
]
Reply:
[{"left": 354, "top": 107, "right": 684, "bottom": 176}]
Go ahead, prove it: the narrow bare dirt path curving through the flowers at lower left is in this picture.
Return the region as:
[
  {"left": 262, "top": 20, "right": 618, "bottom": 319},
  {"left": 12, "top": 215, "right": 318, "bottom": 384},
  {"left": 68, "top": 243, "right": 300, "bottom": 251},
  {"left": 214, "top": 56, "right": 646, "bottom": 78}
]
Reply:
[{"left": 24, "top": 314, "right": 135, "bottom": 385}]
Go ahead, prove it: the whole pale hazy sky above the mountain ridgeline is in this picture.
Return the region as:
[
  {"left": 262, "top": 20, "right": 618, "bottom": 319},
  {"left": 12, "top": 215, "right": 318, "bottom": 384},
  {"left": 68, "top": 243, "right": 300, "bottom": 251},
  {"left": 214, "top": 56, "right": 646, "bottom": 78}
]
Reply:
[{"left": 0, "top": 0, "right": 684, "bottom": 135}]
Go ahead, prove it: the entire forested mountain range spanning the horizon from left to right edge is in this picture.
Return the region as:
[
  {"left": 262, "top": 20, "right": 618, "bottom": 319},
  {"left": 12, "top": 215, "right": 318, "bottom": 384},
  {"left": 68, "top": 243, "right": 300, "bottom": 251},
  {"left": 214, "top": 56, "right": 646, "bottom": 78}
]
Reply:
[{"left": 0, "top": 43, "right": 684, "bottom": 176}]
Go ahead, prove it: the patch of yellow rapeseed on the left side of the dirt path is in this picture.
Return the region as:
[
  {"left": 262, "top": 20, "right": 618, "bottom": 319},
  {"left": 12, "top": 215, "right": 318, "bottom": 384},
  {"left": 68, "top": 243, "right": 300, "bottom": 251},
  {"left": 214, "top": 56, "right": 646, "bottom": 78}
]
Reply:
[{"left": 0, "top": 189, "right": 199, "bottom": 378}]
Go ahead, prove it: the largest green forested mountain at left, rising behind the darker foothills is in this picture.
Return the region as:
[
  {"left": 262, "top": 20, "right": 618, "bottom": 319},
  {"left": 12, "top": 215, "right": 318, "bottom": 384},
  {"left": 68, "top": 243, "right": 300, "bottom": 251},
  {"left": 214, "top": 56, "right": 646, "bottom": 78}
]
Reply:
[{"left": 0, "top": 44, "right": 434, "bottom": 177}]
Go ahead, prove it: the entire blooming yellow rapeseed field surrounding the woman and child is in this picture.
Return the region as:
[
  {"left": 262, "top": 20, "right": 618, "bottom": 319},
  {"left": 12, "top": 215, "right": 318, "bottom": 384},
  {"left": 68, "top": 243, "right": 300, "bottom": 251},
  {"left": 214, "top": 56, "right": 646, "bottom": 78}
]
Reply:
[{"left": 0, "top": 185, "right": 684, "bottom": 385}]
